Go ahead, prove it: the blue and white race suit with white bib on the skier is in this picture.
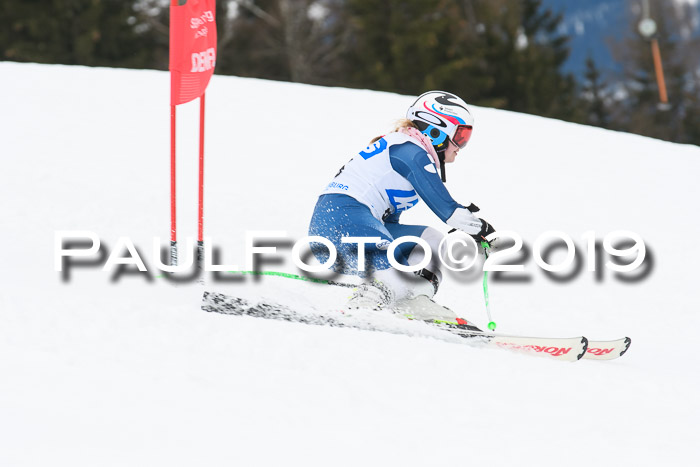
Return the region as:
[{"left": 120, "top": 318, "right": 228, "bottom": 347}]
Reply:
[{"left": 309, "top": 132, "right": 481, "bottom": 276}]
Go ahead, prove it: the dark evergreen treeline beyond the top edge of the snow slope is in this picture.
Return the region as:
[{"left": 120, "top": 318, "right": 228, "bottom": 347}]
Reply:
[{"left": 0, "top": 0, "right": 700, "bottom": 144}]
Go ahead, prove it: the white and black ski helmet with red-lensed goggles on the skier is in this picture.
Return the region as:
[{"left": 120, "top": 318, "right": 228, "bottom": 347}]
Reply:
[{"left": 406, "top": 91, "right": 474, "bottom": 153}]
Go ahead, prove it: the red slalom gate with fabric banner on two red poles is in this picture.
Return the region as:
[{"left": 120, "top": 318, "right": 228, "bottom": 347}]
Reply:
[{"left": 169, "top": 0, "right": 216, "bottom": 266}]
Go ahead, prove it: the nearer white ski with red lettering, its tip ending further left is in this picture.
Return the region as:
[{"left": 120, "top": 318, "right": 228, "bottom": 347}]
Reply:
[{"left": 201, "top": 291, "right": 588, "bottom": 361}]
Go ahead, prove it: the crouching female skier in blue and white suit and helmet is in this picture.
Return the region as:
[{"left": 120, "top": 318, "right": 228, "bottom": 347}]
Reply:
[{"left": 309, "top": 91, "right": 494, "bottom": 324}]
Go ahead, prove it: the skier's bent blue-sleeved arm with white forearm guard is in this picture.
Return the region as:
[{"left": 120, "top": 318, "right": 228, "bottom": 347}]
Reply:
[{"left": 389, "top": 142, "right": 482, "bottom": 234}]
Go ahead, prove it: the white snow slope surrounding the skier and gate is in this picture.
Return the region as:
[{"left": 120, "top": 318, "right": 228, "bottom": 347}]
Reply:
[{"left": 0, "top": 62, "right": 700, "bottom": 467}]
